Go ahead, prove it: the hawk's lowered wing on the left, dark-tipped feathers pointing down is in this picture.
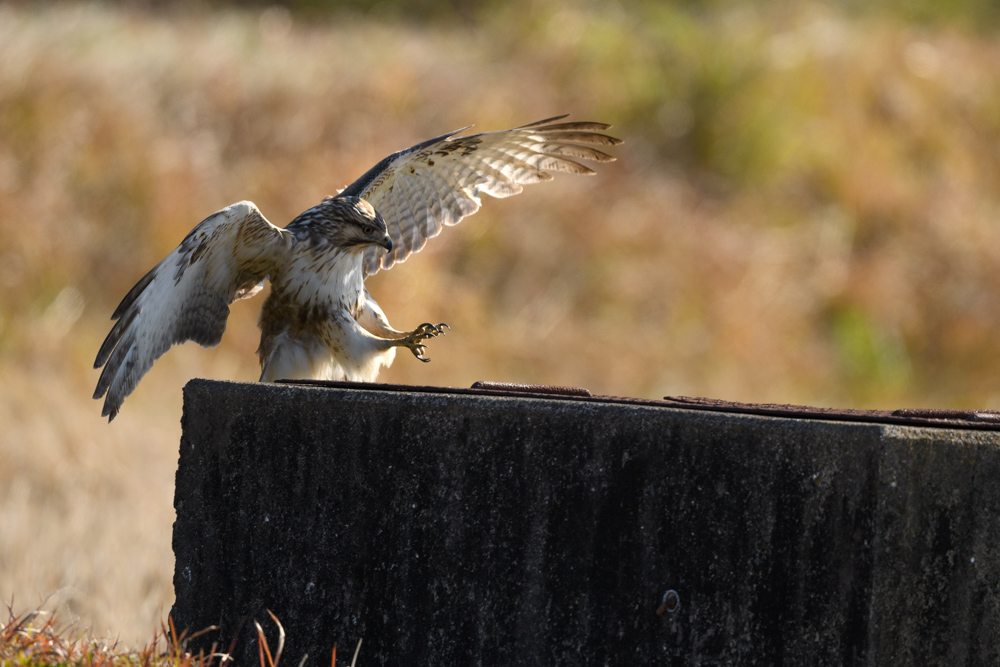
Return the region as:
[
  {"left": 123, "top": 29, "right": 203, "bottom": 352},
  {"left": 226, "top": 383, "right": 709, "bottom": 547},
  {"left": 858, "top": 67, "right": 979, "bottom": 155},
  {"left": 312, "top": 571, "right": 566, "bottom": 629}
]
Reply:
[{"left": 94, "top": 201, "right": 293, "bottom": 421}]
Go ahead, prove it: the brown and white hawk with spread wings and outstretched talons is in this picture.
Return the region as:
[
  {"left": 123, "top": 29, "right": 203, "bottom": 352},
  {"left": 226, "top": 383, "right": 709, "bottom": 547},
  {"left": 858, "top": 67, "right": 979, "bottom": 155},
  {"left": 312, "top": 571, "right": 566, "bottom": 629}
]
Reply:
[{"left": 94, "top": 116, "right": 621, "bottom": 421}]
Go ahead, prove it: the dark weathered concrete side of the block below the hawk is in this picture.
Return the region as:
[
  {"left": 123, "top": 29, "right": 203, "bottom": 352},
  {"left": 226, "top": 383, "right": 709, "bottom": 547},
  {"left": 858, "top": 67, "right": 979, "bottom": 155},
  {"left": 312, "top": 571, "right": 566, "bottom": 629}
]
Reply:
[{"left": 173, "top": 380, "right": 1000, "bottom": 666}]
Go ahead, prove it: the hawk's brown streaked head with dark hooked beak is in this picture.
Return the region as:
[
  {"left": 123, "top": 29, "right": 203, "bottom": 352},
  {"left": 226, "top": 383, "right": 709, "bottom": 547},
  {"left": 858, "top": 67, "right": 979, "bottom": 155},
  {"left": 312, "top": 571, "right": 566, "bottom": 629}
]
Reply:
[{"left": 289, "top": 197, "right": 392, "bottom": 251}]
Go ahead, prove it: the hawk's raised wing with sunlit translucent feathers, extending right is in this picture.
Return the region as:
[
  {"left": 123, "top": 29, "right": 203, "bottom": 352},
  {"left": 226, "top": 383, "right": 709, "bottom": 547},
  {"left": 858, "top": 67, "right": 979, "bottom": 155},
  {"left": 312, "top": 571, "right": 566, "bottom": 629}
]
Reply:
[{"left": 338, "top": 116, "right": 622, "bottom": 276}]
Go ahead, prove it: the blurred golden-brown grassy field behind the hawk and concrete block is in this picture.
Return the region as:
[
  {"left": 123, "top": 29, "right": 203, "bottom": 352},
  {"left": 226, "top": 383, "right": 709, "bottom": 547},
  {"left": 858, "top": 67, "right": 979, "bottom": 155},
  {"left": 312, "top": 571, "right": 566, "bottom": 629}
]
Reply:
[{"left": 0, "top": 0, "right": 1000, "bottom": 643}]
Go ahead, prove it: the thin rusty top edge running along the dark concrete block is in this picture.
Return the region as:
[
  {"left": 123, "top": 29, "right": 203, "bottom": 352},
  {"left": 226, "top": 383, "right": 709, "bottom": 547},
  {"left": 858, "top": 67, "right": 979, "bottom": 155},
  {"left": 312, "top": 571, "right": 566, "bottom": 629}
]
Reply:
[{"left": 182, "top": 378, "right": 1000, "bottom": 431}]
